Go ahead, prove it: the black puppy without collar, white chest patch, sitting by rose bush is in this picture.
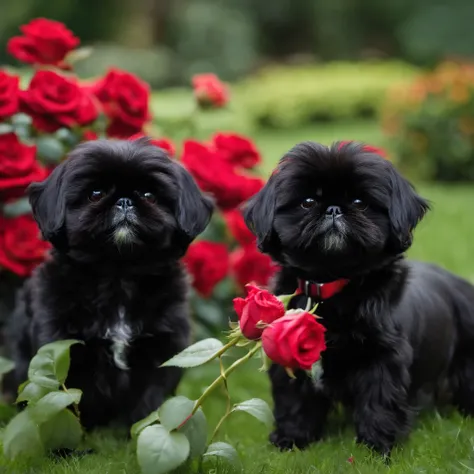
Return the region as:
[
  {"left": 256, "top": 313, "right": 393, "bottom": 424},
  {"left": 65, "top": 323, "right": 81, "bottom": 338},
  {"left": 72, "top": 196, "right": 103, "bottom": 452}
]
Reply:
[{"left": 5, "top": 140, "right": 213, "bottom": 428}]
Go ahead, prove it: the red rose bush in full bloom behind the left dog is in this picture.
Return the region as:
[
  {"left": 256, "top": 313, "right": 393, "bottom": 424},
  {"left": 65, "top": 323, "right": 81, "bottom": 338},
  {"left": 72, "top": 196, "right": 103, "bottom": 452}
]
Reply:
[{"left": 0, "top": 18, "right": 275, "bottom": 336}]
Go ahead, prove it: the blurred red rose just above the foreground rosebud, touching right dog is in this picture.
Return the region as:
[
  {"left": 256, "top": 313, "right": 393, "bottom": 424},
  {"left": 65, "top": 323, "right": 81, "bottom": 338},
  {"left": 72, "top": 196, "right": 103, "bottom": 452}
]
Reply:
[{"left": 230, "top": 244, "right": 278, "bottom": 287}]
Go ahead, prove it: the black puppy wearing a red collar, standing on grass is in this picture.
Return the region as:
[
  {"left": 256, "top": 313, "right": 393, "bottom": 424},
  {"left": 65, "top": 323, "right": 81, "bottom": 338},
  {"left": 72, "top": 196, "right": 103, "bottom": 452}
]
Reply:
[{"left": 245, "top": 142, "right": 474, "bottom": 455}]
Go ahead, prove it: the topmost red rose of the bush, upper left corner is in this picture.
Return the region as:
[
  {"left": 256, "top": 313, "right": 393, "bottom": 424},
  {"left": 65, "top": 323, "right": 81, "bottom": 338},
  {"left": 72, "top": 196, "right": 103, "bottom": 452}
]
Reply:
[{"left": 7, "top": 18, "right": 80, "bottom": 68}]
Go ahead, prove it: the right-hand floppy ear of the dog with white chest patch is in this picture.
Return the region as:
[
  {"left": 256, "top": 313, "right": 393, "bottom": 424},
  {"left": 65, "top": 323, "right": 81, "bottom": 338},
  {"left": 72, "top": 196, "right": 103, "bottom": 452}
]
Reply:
[{"left": 175, "top": 163, "right": 214, "bottom": 243}]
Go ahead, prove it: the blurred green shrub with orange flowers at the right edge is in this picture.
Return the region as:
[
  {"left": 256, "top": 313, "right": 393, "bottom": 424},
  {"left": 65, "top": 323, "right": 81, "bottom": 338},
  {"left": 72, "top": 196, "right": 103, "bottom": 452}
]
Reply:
[{"left": 384, "top": 62, "right": 474, "bottom": 181}]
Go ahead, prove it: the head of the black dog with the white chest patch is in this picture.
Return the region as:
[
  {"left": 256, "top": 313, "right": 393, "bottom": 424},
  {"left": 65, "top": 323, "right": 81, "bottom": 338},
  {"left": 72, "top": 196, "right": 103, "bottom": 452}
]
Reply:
[{"left": 29, "top": 140, "right": 212, "bottom": 259}]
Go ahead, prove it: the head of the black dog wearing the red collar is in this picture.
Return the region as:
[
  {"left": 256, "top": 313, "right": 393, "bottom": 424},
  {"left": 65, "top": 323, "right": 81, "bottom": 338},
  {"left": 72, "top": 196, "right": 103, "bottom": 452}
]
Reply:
[{"left": 245, "top": 142, "right": 428, "bottom": 278}]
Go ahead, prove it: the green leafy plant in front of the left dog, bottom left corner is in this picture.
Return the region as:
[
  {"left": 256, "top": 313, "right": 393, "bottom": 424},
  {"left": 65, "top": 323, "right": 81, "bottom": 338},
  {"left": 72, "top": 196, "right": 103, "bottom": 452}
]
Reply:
[{"left": 3, "top": 340, "right": 83, "bottom": 459}]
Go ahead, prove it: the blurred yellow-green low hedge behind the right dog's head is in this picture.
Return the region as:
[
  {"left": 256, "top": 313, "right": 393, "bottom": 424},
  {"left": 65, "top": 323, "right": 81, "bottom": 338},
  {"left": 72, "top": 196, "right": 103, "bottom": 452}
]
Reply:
[{"left": 240, "top": 61, "right": 418, "bottom": 129}]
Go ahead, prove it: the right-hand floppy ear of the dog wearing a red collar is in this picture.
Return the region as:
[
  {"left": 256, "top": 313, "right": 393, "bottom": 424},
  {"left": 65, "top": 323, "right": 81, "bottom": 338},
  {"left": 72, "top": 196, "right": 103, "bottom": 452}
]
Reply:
[{"left": 388, "top": 164, "right": 430, "bottom": 253}]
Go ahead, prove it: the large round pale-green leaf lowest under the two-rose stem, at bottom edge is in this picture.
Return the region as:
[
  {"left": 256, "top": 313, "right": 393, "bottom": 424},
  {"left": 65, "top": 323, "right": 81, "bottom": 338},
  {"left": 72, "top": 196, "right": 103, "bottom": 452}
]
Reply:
[{"left": 137, "top": 425, "right": 189, "bottom": 474}]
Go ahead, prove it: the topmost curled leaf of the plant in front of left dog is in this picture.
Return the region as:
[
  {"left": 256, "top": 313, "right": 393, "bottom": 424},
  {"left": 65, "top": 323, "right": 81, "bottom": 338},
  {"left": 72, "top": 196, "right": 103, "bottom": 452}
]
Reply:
[{"left": 28, "top": 339, "right": 84, "bottom": 390}]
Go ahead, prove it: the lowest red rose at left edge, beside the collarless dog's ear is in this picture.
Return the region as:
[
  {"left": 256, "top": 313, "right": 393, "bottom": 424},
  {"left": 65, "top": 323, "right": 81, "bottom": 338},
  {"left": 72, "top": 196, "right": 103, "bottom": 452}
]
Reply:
[{"left": 0, "top": 215, "right": 50, "bottom": 277}]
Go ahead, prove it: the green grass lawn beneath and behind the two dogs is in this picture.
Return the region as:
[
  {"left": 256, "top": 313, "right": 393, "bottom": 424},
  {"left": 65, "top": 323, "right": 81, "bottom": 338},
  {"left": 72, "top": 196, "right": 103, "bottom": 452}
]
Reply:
[{"left": 0, "top": 123, "right": 474, "bottom": 474}]
